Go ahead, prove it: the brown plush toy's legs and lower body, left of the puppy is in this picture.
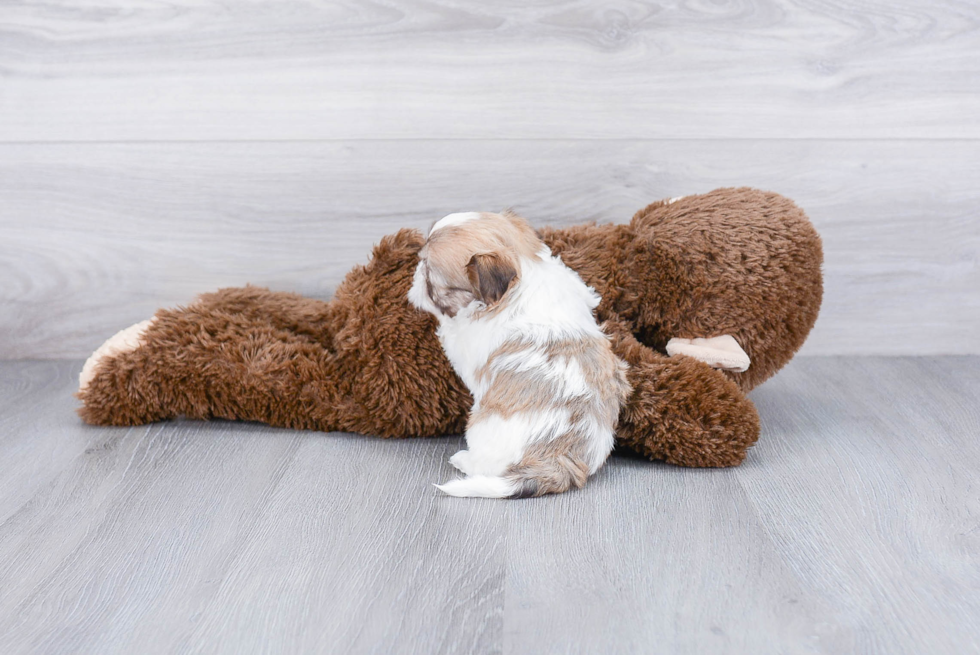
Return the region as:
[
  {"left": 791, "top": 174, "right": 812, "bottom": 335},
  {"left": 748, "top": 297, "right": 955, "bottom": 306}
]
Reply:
[{"left": 77, "top": 230, "right": 472, "bottom": 437}]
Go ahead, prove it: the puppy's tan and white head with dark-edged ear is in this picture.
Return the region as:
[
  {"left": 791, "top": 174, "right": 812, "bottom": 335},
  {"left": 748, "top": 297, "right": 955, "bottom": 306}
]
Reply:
[{"left": 408, "top": 212, "right": 543, "bottom": 318}]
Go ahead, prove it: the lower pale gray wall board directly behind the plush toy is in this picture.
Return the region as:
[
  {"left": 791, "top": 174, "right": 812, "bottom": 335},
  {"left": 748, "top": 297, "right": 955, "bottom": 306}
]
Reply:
[{"left": 0, "top": 140, "right": 980, "bottom": 358}]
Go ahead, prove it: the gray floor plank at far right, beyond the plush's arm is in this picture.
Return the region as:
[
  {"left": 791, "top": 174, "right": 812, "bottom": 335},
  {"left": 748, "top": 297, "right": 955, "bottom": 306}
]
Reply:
[{"left": 739, "top": 357, "right": 980, "bottom": 653}]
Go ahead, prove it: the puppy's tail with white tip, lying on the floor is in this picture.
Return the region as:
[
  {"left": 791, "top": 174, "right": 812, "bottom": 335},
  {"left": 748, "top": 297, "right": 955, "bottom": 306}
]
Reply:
[{"left": 435, "top": 456, "right": 589, "bottom": 498}]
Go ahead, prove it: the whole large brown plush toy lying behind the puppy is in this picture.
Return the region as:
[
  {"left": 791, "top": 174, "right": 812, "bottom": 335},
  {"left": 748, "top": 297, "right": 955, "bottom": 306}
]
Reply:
[{"left": 78, "top": 188, "right": 823, "bottom": 466}]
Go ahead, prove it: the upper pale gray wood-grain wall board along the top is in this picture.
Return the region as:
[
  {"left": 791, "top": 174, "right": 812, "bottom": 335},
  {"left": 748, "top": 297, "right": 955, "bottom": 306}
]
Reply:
[{"left": 0, "top": 0, "right": 980, "bottom": 142}]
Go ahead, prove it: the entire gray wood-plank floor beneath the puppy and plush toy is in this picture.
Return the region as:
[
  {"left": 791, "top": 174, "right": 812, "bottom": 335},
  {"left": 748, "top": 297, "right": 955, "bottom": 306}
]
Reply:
[{"left": 0, "top": 356, "right": 980, "bottom": 654}]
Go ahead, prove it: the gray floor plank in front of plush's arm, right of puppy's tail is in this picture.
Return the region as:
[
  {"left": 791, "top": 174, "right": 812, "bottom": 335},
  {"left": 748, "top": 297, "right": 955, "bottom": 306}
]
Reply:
[{"left": 504, "top": 464, "right": 856, "bottom": 653}]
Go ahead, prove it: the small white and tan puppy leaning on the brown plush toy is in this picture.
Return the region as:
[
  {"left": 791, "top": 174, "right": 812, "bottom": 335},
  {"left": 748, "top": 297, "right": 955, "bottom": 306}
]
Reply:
[{"left": 409, "top": 212, "right": 630, "bottom": 498}]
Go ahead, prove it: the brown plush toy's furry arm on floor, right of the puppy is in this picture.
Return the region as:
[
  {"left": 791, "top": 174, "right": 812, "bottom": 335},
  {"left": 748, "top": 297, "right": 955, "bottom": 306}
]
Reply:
[{"left": 607, "top": 324, "right": 759, "bottom": 467}]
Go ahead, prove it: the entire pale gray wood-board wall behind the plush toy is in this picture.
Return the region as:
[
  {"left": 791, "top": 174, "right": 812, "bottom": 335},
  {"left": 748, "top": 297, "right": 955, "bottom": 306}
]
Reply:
[{"left": 0, "top": 0, "right": 980, "bottom": 358}]
